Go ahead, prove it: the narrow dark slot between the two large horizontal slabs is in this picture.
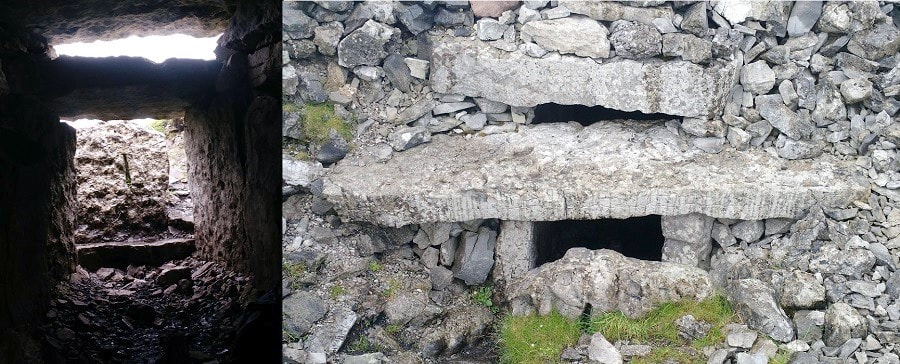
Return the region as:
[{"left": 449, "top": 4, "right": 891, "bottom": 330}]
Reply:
[{"left": 531, "top": 104, "right": 680, "bottom": 126}]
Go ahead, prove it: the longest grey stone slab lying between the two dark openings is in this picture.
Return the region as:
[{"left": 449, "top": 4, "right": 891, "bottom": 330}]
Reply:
[{"left": 325, "top": 122, "right": 868, "bottom": 226}]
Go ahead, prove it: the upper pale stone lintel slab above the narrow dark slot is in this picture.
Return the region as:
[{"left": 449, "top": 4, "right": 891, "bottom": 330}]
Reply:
[{"left": 430, "top": 38, "right": 737, "bottom": 118}]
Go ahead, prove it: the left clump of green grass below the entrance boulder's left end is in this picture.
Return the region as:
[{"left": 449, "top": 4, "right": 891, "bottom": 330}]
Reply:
[{"left": 500, "top": 312, "right": 581, "bottom": 364}]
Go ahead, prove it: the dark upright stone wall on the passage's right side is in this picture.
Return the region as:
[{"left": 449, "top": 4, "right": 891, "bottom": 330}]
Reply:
[{"left": 191, "top": 2, "right": 281, "bottom": 290}]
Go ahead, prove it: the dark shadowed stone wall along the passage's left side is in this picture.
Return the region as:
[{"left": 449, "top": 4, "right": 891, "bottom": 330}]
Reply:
[{"left": 0, "top": 28, "right": 76, "bottom": 362}]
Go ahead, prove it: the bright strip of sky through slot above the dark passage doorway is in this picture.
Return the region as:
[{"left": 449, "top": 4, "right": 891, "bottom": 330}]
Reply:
[{"left": 53, "top": 34, "right": 221, "bottom": 63}]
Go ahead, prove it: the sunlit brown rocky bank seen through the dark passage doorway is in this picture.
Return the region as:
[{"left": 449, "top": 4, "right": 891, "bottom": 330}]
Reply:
[{"left": 64, "top": 118, "right": 194, "bottom": 246}]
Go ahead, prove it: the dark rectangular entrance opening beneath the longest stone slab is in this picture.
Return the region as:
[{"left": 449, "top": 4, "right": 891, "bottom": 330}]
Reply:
[{"left": 534, "top": 215, "right": 665, "bottom": 265}]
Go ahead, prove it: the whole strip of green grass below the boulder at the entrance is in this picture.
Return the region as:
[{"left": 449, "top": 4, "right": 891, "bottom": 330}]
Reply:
[{"left": 499, "top": 295, "right": 740, "bottom": 364}]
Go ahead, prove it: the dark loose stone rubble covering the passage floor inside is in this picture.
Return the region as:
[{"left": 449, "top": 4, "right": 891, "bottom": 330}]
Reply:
[{"left": 40, "top": 258, "right": 248, "bottom": 363}]
